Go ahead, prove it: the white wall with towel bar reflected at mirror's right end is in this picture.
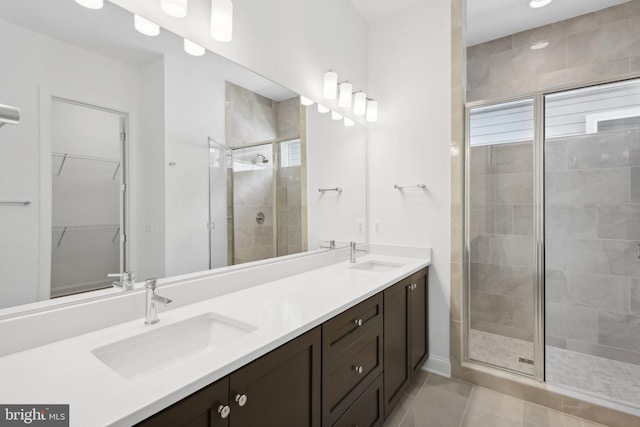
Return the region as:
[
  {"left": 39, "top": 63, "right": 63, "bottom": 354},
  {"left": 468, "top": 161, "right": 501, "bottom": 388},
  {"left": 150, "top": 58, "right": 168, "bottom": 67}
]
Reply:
[{"left": 307, "top": 106, "right": 367, "bottom": 250}]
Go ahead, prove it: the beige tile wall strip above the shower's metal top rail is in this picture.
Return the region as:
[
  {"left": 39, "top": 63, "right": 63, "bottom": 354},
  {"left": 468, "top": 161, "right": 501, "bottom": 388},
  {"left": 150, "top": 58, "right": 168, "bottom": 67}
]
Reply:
[{"left": 467, "top": 0, "right": 640, "bottom": 102}]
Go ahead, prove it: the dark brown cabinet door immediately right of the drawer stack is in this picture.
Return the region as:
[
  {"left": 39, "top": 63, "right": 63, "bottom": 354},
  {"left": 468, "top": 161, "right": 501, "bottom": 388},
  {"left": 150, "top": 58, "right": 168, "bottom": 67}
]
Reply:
[{"left": 383, "top": 277, "right": 411, "bottom": 416}]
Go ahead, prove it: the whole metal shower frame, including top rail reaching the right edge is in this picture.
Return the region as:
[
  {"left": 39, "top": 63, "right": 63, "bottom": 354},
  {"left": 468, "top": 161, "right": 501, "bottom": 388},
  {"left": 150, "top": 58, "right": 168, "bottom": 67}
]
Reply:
[{"left": 460, "top": 74, "right": 640, "bottom": 383}]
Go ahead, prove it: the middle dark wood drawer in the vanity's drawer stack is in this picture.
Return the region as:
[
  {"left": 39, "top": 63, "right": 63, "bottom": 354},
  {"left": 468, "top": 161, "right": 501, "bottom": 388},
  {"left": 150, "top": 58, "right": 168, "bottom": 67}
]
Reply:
[{"left": 322, "top": 333, "right": 383, "bottom": 426}]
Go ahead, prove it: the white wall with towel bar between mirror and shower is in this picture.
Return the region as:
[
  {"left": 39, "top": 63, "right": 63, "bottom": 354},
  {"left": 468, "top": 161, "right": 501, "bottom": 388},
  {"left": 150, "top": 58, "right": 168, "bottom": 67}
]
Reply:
[{"left": 367, "top": 0, "right": 451, "bottom": 372}]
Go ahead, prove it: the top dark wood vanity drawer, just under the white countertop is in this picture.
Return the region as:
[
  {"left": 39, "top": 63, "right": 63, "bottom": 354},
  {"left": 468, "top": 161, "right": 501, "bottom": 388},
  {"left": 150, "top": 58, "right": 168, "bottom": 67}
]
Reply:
[{"left": 322, "top": 292, "right": 383, "bottom": 360}]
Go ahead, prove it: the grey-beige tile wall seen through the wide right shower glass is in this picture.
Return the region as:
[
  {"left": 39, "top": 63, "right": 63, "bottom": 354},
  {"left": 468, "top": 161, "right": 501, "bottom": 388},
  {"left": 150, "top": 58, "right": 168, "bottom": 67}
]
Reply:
[{"left": 545, "top": 130, "right": 640, "bottom": 364}]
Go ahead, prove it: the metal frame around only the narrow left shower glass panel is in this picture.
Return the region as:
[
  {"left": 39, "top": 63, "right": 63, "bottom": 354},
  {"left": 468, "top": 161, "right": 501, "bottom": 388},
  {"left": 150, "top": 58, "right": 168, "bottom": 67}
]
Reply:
[{"left": 461, "top": 93, "right": 546, "bottom": 383}]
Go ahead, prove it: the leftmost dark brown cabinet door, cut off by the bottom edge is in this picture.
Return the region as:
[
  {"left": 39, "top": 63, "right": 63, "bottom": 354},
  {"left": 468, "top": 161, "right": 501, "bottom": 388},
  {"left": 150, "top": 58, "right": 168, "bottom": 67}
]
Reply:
[{"left": 137, "top": 378, "right": 229, "bottom": 427}]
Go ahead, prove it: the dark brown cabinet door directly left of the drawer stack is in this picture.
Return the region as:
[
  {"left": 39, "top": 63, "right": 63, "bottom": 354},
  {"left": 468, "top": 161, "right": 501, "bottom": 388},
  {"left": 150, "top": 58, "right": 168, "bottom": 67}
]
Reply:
[{"left": 229, "top": 327, "right": 321, "bottom": 427}]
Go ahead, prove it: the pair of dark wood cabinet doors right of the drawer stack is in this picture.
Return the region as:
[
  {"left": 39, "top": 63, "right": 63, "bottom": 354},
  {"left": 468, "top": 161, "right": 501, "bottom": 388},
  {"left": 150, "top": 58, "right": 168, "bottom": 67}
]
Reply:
[{"left": 384, "top": 269, "right": 429, "bottom": 416}]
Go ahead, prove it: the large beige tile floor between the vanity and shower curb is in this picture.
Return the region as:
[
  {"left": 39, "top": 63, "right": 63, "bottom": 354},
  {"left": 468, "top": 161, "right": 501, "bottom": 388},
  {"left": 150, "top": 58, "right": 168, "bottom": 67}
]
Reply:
[{"left": 383, "top": 371, "right": 602, "bottom": 427}]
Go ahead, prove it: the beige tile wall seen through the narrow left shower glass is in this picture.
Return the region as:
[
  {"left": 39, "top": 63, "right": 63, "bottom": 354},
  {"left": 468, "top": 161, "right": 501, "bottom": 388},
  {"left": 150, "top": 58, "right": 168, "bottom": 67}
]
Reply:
[{"left": 469, "top": 142, "right": 534, "bottom": 342}]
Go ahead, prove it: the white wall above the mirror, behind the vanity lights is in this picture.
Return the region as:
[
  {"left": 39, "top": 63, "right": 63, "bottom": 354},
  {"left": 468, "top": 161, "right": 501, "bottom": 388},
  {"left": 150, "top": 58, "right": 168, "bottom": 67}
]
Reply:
[{"left": 112, "top": 0, "right": 367, "bottom": 117}]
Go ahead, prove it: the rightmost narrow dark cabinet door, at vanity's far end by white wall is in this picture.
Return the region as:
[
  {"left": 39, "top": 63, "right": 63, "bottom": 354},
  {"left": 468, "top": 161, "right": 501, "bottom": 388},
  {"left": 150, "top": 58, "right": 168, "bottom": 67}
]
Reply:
[{"left": 409, "top": 269, "right": 429, "bottom": 378}]
